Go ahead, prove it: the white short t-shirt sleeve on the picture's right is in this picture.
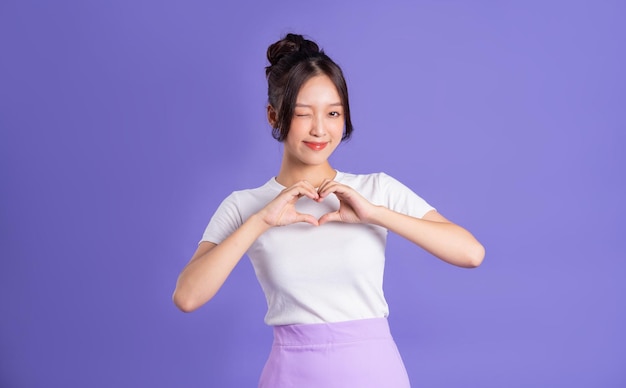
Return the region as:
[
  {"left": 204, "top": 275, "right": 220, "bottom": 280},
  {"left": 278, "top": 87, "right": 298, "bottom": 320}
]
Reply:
[{"left": 379, "top": 173, "right": 435, "bottom": 218}]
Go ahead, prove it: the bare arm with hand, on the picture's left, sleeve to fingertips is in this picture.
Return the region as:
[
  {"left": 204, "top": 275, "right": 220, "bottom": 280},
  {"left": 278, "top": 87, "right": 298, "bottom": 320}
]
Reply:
[{"left": 172, "top": 182, "right": 319, "bottom": 312}]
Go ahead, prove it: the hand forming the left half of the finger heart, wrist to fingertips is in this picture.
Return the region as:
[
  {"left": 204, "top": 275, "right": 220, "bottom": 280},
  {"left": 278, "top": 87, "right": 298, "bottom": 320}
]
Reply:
[{"left": 258, "top": 181, "right": 319, "bottom": 226}]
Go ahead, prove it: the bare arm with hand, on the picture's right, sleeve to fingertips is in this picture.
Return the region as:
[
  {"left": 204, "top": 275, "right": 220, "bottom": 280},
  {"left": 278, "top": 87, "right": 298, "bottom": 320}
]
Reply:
[{"left": 318, "top": 181, "right": 485, "bottom": 268}]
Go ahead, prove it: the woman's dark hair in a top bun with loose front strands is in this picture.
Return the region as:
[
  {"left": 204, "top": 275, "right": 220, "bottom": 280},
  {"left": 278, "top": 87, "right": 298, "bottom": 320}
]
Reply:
[{"left": 265, "top": 34, "right": 352, "bottom": 142}]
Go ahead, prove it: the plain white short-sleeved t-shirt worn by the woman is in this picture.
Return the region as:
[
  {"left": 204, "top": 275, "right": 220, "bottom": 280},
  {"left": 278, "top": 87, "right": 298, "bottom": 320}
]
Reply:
[{"left": 202, "top": 171, "right": 434, "bottom": 325}]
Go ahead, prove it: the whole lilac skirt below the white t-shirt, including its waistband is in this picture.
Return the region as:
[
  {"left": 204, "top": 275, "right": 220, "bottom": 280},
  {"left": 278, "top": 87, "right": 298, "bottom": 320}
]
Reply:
[{"left": 259, "top": 318, "right": 410, "bottom": 388}]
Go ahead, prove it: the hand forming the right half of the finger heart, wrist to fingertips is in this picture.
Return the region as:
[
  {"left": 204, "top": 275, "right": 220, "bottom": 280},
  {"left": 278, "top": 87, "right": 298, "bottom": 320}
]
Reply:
[{"left": 317, "top": 180, "right": 376, "bottom": 225}]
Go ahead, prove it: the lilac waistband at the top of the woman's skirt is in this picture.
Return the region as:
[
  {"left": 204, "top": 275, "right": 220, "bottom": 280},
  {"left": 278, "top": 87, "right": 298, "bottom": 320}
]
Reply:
[{"left": 274, "top": 318, "right": 391, "bottom": 346}]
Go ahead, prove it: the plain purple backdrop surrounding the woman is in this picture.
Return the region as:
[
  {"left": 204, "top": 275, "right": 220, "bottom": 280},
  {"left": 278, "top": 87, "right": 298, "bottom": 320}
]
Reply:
[{"left": 0, "top": 0, "right": 626, "bottom": 387}]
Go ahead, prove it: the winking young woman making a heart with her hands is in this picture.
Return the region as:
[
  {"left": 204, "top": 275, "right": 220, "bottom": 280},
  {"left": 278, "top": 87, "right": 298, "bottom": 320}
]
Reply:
[{"left": 173, "top": 34, "right": 484, "bottom": 388}]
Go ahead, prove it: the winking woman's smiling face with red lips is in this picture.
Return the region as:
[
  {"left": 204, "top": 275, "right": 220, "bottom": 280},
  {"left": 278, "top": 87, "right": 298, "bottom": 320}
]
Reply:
[{"left": 284, "top": 75, "right": 345, "bottom": 165}]
